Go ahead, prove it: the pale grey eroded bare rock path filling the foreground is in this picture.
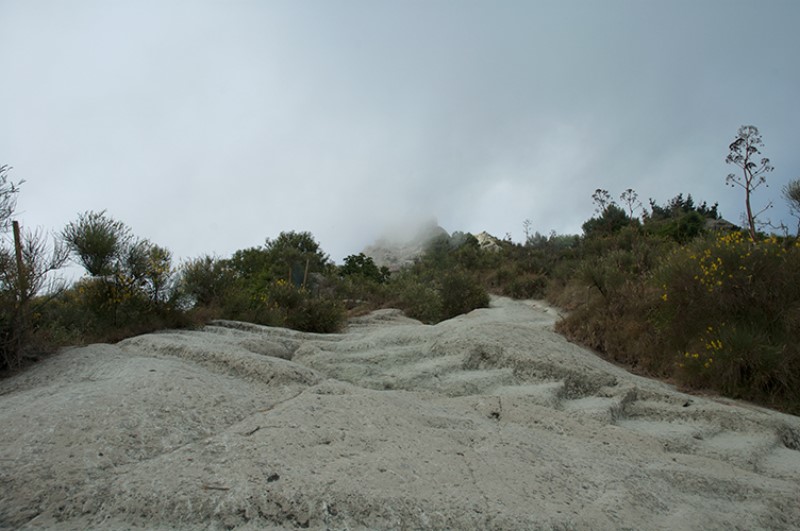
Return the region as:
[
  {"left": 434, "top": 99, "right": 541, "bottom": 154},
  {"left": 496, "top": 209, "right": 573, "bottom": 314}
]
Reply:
[{"left": 0, "top": 298, "right": 800, "bottom": 530}]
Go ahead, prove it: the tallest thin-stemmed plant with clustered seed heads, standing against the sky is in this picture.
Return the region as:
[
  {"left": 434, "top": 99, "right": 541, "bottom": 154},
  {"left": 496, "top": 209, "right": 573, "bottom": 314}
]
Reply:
[{"left": 725, "top": 125, "right": 774, "bottom": 241}]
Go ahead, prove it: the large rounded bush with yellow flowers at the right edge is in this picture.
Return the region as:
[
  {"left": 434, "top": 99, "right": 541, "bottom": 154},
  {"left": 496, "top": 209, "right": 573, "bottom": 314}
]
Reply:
[{"left": 654, "top": 232, "right": 800, "bottom": 410}]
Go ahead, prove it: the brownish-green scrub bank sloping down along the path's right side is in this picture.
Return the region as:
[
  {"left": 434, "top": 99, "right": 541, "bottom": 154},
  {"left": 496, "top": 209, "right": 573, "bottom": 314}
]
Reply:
[{"left": 557, "top": 230, "right": 800, "bottom": 412}]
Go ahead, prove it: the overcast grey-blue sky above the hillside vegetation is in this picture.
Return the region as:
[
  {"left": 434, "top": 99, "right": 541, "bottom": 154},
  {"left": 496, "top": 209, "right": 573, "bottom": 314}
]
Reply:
[{"left": 0, "top": 0, "right": 800, "bottom": 263}]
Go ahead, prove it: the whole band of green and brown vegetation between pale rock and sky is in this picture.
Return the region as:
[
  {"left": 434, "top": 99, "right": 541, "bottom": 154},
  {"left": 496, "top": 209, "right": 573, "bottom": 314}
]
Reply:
[{"left": 6, "top": 150, "right": 800, "bottom": 412}]
